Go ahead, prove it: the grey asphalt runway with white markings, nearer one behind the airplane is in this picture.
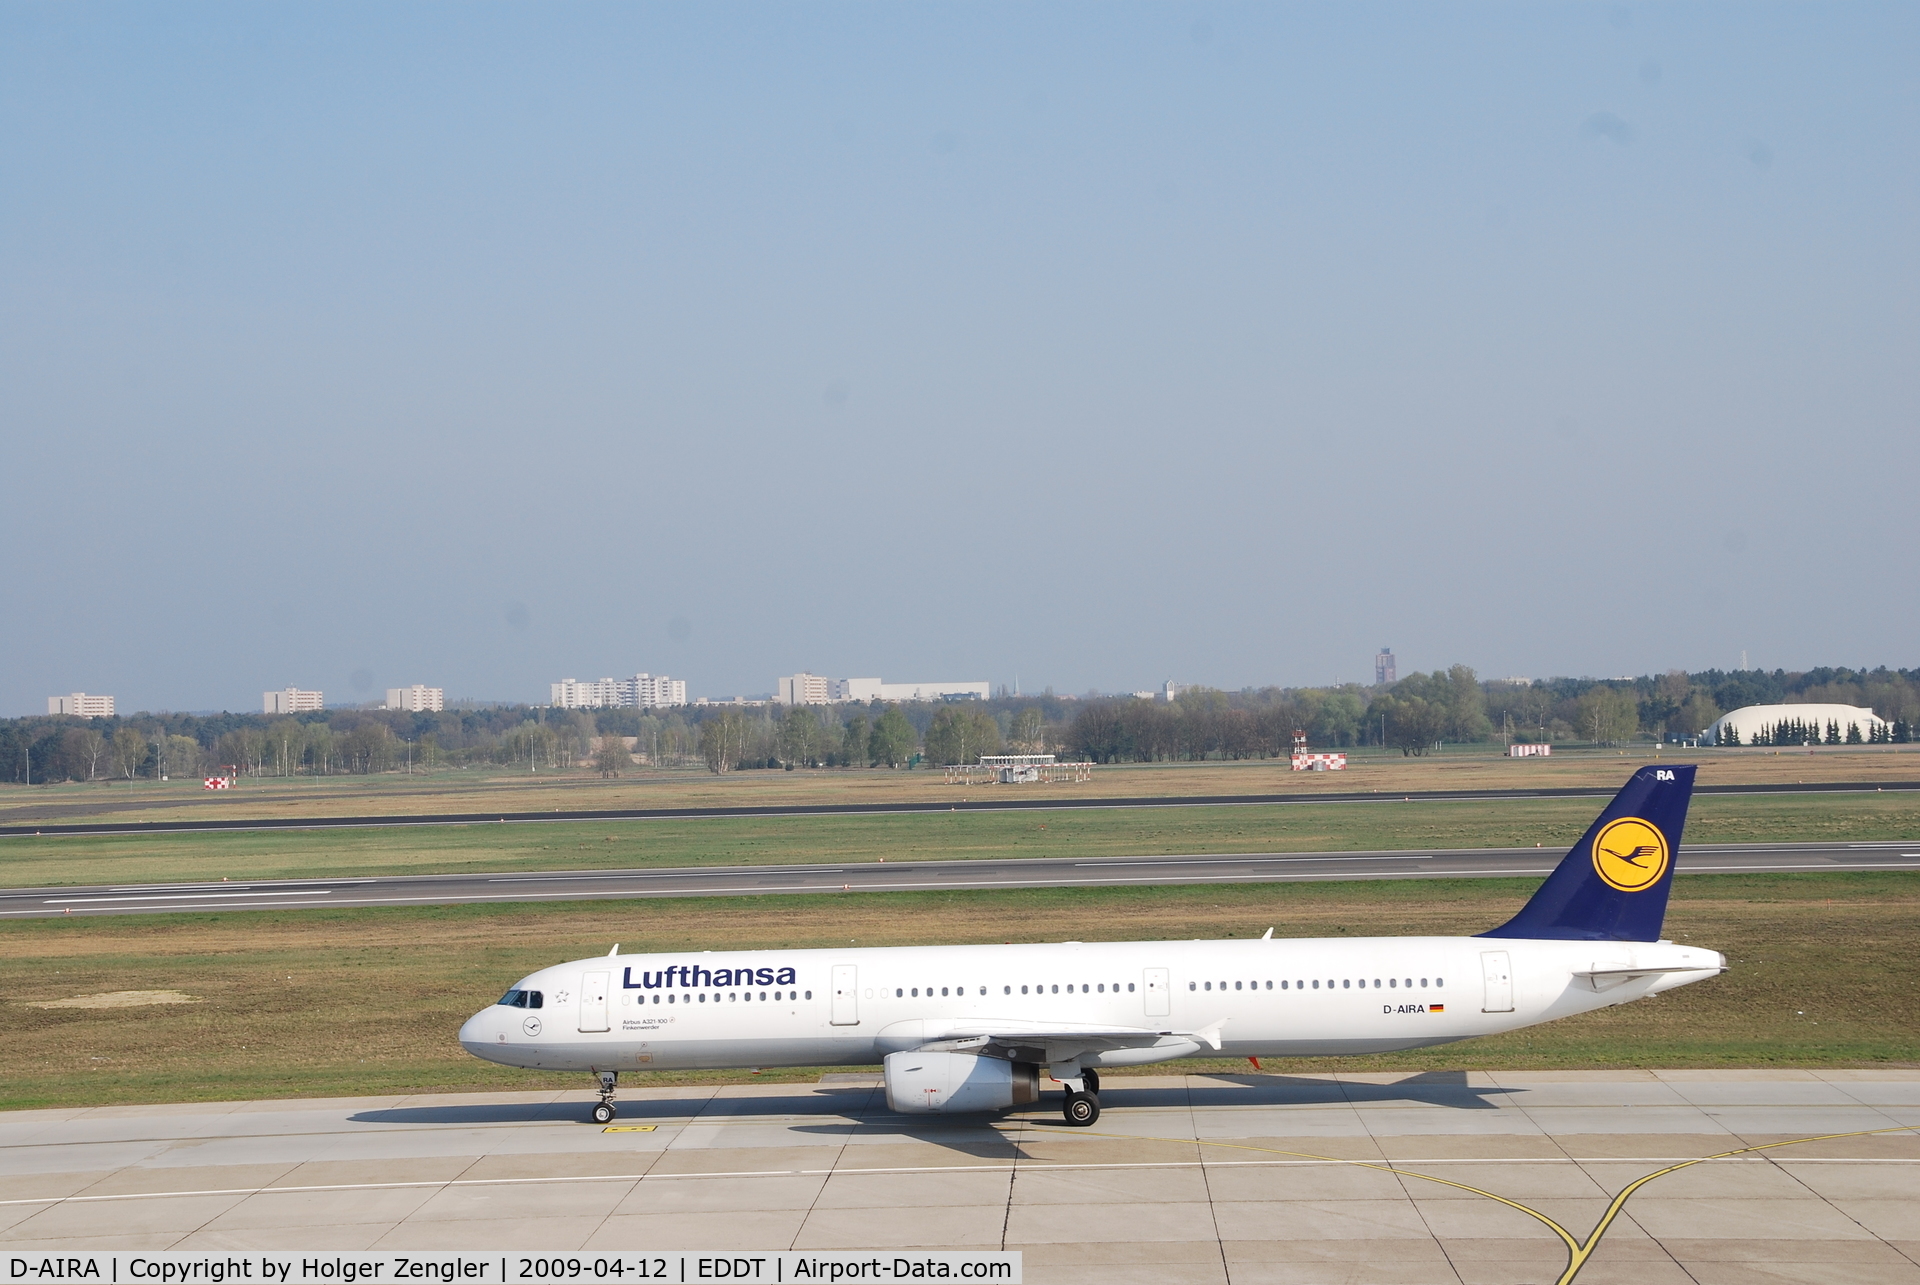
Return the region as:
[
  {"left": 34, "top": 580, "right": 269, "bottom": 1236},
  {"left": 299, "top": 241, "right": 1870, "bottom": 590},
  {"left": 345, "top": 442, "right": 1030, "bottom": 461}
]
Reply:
[{"left": 0, "top": 841, "right": 1920, "bottom": 918}]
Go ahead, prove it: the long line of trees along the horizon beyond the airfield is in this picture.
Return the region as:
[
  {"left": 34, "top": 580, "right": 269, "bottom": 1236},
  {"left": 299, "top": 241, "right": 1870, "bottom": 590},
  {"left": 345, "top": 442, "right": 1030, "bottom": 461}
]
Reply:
[{"left": 0, "top": 665, "right": 1920, "bottom": 784}]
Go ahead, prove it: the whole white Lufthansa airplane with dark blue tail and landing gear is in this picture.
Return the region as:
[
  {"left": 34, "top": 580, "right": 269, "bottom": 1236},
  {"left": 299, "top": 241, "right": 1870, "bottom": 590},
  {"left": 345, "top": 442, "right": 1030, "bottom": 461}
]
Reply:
[{"left": 461, "top": 766, "right": 1726, "bottom": 1126}]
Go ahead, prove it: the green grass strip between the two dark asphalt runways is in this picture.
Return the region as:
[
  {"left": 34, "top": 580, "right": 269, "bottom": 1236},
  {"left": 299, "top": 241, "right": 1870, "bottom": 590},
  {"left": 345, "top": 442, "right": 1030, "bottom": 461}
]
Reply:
[{"left": 0, "top": 793, "right": 1920, "bottom": 887}]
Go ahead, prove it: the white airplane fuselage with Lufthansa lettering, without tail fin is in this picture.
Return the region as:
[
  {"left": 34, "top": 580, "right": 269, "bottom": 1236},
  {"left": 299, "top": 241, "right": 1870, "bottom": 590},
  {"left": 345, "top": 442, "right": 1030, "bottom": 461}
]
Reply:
[{"left": 461, "top": 937, "right": 1724, "bottom": 1072}]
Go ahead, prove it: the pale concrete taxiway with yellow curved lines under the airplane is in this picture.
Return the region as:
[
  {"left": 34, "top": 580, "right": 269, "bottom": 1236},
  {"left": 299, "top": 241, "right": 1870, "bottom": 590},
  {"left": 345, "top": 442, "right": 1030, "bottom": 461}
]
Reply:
[{"left": 0, "top": 1070, "right": 1920, "bottom": 1285}]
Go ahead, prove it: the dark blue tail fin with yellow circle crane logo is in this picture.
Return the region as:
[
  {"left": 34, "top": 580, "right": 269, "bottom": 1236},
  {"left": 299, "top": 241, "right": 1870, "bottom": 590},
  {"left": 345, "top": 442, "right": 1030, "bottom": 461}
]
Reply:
[{"left": 1480, "top": 766, "right": 1693, "bottom": 941}]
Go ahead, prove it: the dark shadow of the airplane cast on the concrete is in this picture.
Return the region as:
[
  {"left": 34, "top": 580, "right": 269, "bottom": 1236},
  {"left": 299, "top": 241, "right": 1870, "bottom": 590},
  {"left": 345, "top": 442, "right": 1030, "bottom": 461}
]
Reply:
[{"left": 349, "top": 1072, "right": 1521, "bottom": 1145}]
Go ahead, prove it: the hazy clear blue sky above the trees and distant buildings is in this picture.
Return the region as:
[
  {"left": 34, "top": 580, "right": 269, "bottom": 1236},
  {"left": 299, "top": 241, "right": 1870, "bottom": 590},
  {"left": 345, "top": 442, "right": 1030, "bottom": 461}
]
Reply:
[{"left": 0, "top": 4, "right": 1920, "bottom": 713}]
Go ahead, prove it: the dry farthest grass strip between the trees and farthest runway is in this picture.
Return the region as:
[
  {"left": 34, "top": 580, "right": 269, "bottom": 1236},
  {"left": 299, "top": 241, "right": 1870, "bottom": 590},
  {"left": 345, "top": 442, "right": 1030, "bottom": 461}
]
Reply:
[{"left": 0, "top": 745, "right": 1920, "bottom": 824}]
